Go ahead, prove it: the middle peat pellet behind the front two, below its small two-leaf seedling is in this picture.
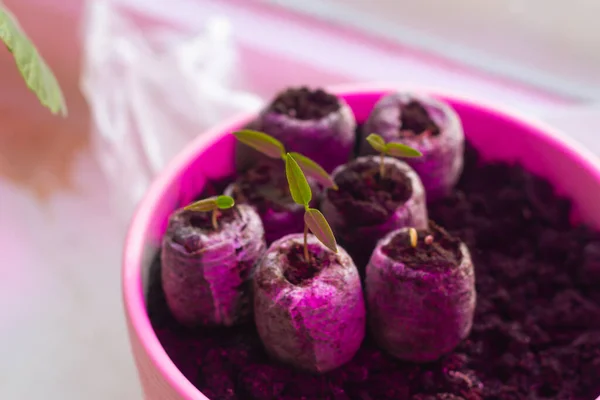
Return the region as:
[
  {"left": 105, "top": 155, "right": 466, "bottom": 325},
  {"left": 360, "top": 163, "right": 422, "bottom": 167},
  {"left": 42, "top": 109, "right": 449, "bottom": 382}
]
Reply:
[{"left": 320, "top": 155, "right": 428, "bottom": 268}]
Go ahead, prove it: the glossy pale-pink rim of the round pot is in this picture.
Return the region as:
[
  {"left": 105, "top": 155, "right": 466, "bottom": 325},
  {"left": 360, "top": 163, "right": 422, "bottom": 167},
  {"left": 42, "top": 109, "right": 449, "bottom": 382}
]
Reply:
[{"left": 122, "top": 83, "right": 600, "bottom": 400}]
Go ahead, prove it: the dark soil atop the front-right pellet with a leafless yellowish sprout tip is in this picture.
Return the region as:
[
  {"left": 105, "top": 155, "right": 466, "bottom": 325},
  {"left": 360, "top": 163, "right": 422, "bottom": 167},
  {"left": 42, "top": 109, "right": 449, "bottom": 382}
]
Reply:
[{"left": 381, "top": 221, "right": 462, "bottom": 271}]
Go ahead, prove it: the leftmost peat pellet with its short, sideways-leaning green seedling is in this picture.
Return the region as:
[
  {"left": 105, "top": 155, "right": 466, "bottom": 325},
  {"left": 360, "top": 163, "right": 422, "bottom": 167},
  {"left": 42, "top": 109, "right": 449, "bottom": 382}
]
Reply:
[{"left": 161, "top": 196, "right": 266, "bottom": 326}]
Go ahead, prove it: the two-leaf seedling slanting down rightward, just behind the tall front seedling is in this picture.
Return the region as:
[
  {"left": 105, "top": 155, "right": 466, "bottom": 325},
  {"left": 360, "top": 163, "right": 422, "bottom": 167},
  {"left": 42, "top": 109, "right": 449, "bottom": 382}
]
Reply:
[{"left": 234, "top": 129, "right": 338, "bottom": 190}]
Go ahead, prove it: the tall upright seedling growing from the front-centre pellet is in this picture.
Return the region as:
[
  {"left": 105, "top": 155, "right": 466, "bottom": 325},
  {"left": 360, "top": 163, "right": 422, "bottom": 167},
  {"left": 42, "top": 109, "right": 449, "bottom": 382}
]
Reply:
[{"left": 284, "top": 153, "right": 337, "bottom": 262}]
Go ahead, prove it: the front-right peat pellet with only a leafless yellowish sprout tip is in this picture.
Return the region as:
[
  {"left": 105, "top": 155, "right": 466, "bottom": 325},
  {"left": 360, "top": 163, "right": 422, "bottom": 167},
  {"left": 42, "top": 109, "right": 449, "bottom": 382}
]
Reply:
[{"left": 365, "top": 221, "right": 476, "bottom": 362}]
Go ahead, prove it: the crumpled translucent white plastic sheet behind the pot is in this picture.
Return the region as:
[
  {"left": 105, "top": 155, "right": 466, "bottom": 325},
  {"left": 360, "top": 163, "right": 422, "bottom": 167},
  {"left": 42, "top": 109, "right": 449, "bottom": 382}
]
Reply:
[{"left": 82, "top": 2, "right": 262, "bottom": 219}]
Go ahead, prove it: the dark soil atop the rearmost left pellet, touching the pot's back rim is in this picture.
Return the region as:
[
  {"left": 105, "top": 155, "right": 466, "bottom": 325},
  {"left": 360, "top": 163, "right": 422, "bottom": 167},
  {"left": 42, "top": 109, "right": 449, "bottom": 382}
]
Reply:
[{"left": 269, "top": 87, "right": 340, "bottom": 120}]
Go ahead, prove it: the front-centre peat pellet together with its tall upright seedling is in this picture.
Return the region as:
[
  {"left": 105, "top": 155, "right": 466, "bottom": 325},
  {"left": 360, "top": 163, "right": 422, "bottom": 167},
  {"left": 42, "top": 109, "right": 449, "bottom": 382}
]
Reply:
[{"left": 254, "top": 153, "right": 366, "bottom": 373}]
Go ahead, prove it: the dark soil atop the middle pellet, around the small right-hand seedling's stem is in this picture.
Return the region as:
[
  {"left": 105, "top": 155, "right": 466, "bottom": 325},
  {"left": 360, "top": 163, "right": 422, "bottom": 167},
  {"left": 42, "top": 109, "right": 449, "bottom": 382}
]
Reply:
[{"left": 327, "top": 161, "right": 412, "bottom": 226}]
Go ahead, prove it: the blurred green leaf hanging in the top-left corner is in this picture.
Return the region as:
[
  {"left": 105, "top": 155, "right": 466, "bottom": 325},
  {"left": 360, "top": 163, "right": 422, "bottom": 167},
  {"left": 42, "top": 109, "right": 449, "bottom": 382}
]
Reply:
[{"left": 0, "top": 3, "right": 67, "bottom": 117}]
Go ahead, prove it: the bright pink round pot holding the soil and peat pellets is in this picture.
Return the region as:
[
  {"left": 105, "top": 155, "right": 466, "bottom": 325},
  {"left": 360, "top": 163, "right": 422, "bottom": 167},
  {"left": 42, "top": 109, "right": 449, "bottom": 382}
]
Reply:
[{"left": 122, "top": 84, "right": 600, "bottom": 400}]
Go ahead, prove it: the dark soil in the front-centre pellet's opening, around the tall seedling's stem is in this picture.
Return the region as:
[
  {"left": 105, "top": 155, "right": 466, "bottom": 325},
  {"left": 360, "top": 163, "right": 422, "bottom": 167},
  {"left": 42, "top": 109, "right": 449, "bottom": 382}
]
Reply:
[{"left": 283, "top": 244, "right": 335, "bottom": 286}]
